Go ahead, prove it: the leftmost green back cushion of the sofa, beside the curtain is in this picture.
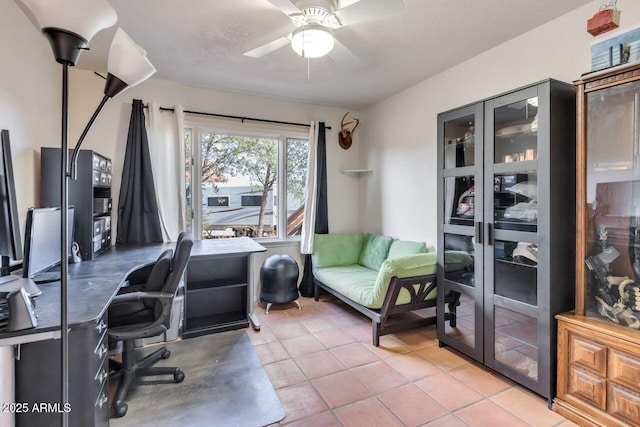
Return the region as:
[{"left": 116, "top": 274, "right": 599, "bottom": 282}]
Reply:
[{"left": 311, "top": 233, "right": 364, "bottom": 269}]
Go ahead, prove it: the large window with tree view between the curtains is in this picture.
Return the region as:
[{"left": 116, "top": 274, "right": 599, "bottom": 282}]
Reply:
[{"left": 184, "top": 125, "right": 309, "bottom": 239}]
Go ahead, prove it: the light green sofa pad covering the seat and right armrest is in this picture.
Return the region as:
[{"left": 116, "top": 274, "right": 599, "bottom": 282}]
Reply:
[{"left": 313, "top": 253, "right": 437, "bottom": 309}]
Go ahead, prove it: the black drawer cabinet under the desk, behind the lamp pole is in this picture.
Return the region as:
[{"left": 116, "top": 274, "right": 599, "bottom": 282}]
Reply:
[{"left": 15, "top": 313, "right": 109, "bottom": 427}]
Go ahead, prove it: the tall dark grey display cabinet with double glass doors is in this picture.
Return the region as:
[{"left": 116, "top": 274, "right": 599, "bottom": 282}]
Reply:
[{"left": 438, "top": 80, "right": 575, "bottom": 401}]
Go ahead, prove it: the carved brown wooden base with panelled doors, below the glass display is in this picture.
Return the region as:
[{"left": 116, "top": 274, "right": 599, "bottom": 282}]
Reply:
[{"left": 553, "top": 314, "right": 640, "bottom": 426}]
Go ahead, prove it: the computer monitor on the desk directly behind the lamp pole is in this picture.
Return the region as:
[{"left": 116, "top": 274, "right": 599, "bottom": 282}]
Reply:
[{"left": 22, "top": 207, "right": 74, "bottom": 283}]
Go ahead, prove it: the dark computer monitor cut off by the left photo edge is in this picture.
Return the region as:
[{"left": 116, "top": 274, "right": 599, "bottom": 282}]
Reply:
[{"left": 0, "top": 129, "right": 22, "bottom": 276}]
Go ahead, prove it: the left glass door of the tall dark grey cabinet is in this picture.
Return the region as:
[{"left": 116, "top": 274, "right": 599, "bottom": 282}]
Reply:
[{"left": 438, "top": 104, "right": 484, "bottom": 361}]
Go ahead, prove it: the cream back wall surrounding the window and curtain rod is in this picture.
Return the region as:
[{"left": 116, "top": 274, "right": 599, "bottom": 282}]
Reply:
[{"left": 70, "top": 69, "right": 360, "bottom": 240}]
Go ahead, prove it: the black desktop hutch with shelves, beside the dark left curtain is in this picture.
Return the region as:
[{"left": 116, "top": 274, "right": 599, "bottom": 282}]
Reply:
[{"left": 40, "top": 147, "right": 112, "bottom": 260}]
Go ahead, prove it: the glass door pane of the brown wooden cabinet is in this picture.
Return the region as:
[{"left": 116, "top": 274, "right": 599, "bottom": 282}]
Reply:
[{"left": 581, "top": 81, "right": 640, "bottom": 330}]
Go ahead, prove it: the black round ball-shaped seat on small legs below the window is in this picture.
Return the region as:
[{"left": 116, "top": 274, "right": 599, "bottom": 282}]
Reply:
[{"left": 260, "top": 254, "right": 302, "bottom": 314}]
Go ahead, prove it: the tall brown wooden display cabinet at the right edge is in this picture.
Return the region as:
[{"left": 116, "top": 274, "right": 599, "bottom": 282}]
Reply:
[{"left": 553, "top": 63, "right": 640, "bottom": 426}]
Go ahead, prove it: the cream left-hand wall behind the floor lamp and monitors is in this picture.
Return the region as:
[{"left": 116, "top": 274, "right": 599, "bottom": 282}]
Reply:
[{"left": 0, "top": 0, "right": 61, "bottom": 427}]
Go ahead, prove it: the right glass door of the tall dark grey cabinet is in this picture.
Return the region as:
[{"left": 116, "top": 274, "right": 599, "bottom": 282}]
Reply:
[{"left": 484, "top": 86, "right": 548, "bottom": 389}]
